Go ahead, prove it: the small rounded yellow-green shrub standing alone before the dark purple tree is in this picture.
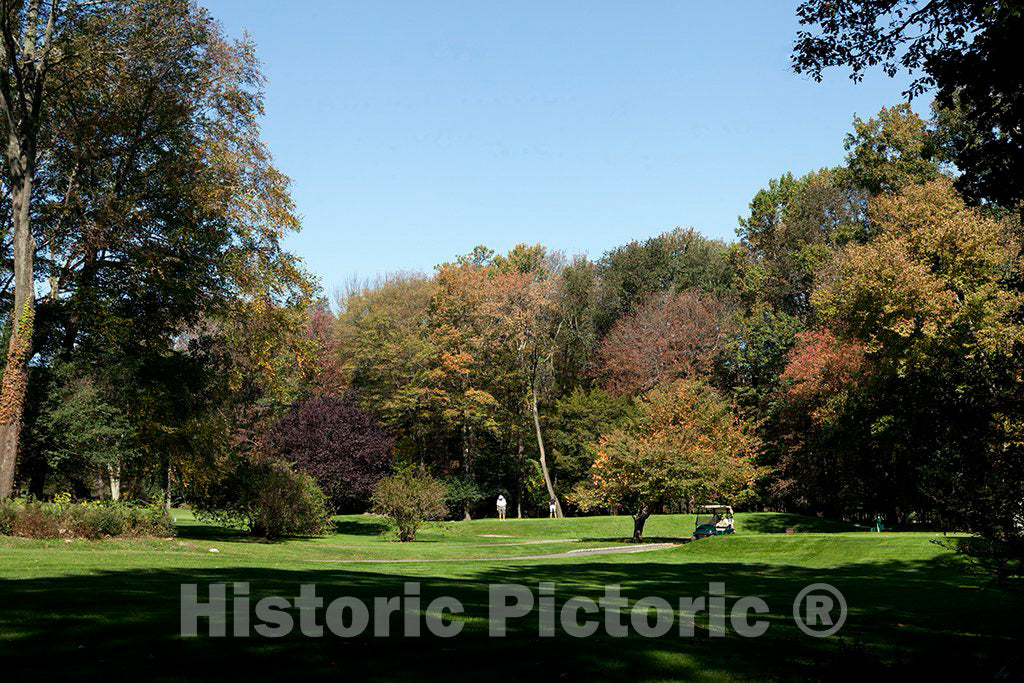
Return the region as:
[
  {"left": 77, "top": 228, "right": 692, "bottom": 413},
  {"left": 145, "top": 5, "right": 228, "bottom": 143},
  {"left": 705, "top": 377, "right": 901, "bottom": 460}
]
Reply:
[{"left": 373, "top": 469, "right": 447, "bottom": 542}]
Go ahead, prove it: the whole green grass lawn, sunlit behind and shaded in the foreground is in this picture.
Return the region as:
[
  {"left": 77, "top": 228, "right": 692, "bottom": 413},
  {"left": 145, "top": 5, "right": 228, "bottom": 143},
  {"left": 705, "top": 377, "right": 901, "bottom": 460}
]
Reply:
[{"left": 0, "top": 511, "right": 1024, "bottom": 681}]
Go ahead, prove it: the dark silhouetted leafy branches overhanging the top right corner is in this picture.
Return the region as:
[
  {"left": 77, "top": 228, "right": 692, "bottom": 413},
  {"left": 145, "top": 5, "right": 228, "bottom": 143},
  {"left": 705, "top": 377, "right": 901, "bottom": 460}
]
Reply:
[{"left": 793, "top": 0, "right": 1024, "bottom": 207}]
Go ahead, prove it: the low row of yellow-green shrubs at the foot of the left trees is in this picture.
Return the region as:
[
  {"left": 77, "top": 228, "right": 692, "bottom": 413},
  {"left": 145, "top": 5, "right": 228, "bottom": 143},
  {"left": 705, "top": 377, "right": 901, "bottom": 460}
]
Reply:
[{"left": 0, "top": 496, "right": 174, "bottom": 539}]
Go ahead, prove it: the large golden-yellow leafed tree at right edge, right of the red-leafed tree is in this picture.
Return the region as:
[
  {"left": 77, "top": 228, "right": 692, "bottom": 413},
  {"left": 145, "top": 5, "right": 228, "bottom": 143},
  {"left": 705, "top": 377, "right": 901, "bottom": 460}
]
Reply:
[{"left": 786, "top": 179, "right": 1024, "bottom": 520}]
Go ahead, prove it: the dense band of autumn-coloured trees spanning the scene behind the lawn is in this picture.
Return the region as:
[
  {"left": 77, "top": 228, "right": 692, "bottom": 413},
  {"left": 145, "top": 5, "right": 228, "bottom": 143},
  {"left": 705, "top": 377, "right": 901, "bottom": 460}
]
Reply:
[{"left": 0, "top": 0, "right": 1024, "bottom": 565}]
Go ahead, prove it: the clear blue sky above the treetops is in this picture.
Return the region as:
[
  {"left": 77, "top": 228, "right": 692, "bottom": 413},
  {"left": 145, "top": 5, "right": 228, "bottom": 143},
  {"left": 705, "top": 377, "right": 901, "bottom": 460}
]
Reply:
[{"left": 202, "top": 0, "right": 926, "bottom": 294}]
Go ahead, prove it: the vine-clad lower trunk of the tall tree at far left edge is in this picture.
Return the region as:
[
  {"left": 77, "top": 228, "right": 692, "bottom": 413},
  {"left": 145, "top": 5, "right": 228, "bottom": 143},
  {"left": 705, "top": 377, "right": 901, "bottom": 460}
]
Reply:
[{"left": 0, "top": 174, "right": 36, "bottom": 500}]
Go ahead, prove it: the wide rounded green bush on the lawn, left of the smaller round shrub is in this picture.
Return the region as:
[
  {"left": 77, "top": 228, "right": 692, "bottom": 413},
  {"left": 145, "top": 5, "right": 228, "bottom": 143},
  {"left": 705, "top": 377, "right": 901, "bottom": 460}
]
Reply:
[{"left": 194, "top": 459, "right": 331, "bottom": 539}]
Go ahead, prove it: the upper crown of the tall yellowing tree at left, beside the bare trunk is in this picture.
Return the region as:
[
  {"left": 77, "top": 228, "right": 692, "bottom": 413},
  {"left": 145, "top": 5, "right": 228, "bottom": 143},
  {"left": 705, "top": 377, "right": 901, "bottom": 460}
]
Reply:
[{"left": 0, "top": 0, "right": 313, "bottom": 501}]
